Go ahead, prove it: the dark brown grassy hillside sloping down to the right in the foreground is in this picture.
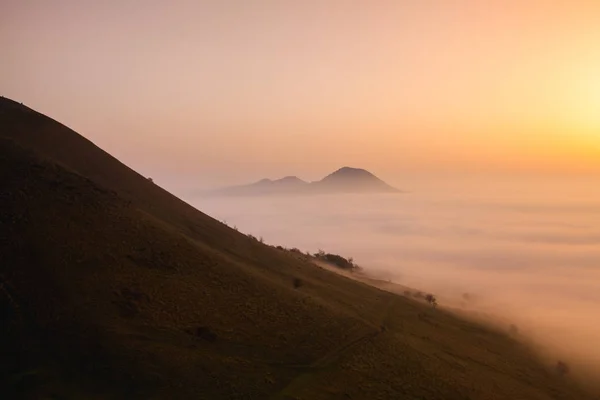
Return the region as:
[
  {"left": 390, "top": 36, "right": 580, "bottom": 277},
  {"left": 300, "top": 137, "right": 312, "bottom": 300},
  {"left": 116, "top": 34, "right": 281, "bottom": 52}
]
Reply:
[{"left": 0, "top": 98, "right": 590, "bottom": 400}]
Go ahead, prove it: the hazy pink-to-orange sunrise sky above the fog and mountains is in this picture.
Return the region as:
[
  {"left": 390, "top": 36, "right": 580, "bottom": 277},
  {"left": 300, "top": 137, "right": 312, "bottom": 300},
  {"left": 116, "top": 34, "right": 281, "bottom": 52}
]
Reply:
[{"left": 0, "top": 0, "right": 600, "bottom": 186}]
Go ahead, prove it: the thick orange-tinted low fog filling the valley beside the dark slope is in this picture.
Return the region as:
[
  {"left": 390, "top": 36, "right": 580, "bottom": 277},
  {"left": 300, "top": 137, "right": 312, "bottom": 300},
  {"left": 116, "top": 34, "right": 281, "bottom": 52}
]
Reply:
[{"left": 188, "top": 180, "right": 600, "bottom": 382}]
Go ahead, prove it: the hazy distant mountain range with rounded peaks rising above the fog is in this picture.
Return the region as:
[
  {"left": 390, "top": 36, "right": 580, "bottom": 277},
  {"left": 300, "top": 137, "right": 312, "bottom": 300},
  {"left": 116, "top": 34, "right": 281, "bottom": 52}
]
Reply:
[{"left": 210, "top": 167, "right": 400, "bottom": 196}]
